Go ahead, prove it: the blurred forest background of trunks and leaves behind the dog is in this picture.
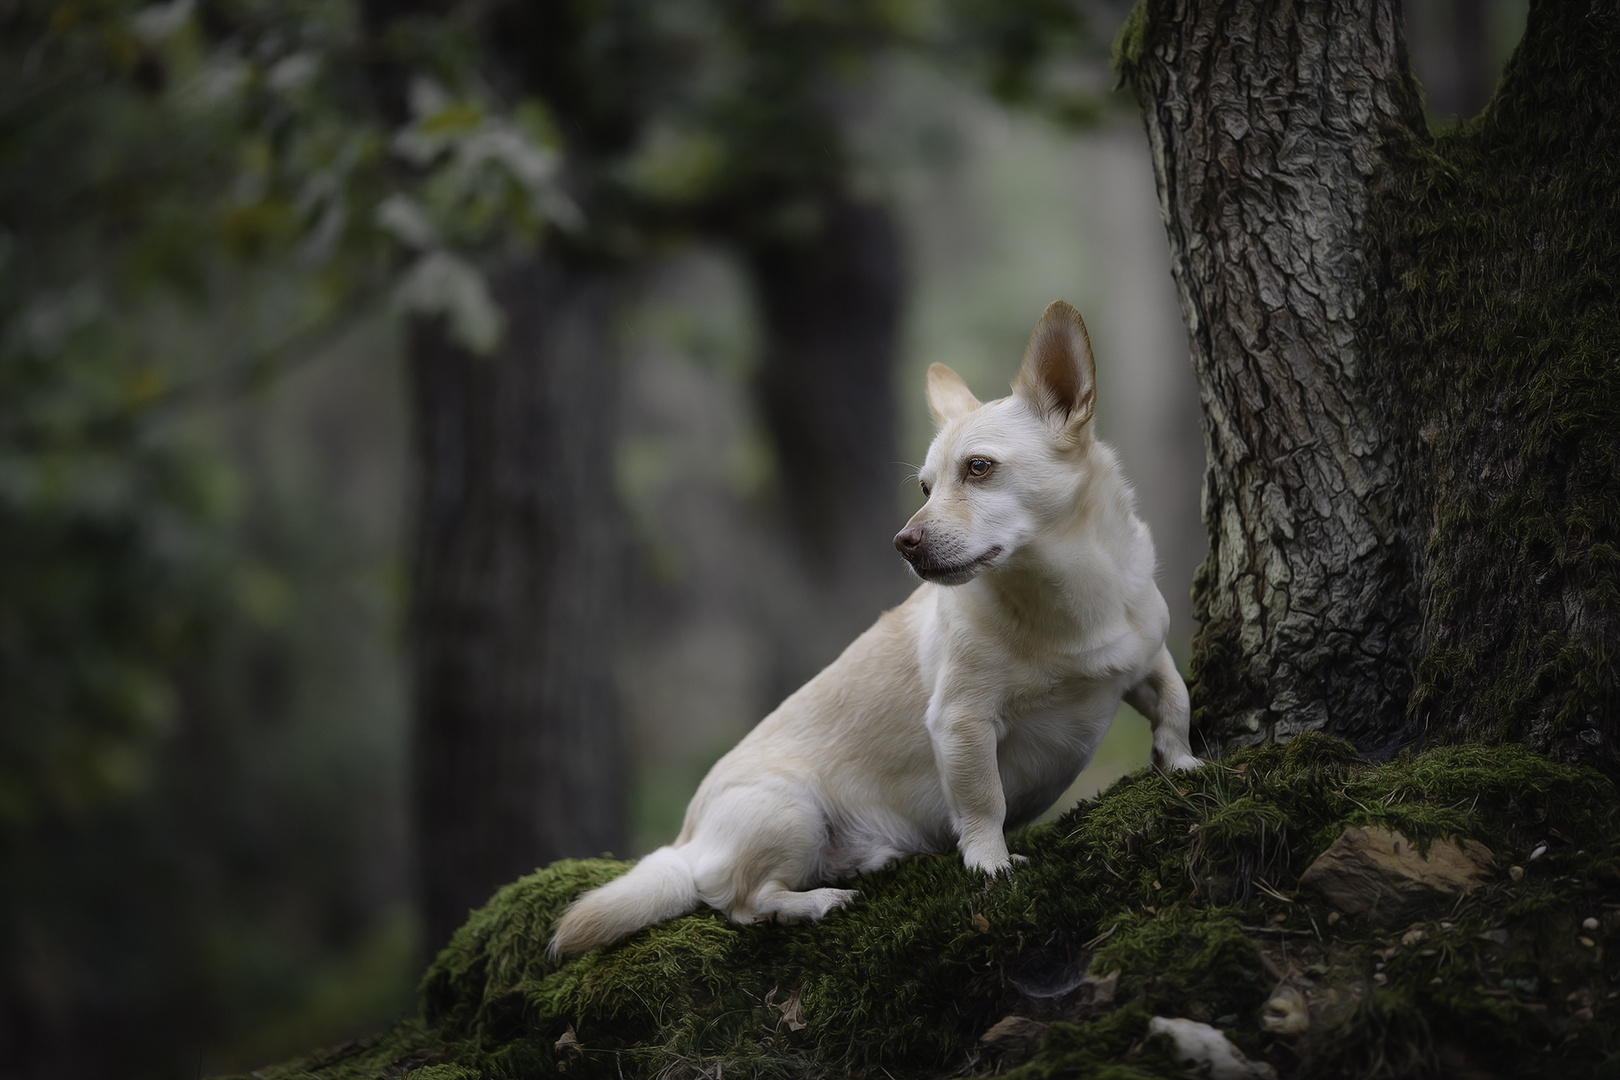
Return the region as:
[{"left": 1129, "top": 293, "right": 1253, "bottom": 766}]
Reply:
[{"left": 0, "top": 0, "right": 1523, "bottom": 1078}]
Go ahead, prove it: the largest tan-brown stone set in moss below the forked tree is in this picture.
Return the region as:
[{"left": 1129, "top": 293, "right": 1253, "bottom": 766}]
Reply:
[{"left": 1299, "top": 826, "right": 1494, "bottom": 920}]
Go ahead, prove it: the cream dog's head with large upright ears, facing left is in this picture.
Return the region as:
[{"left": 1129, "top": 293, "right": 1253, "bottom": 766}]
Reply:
[{"left": 894, "top": 300, "right": 1097, "bottom": 585}]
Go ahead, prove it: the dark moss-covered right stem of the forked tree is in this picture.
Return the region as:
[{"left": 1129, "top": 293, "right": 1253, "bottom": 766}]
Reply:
[{"left": 1371, "top": 3, "right": 1620, "bottom": 769}]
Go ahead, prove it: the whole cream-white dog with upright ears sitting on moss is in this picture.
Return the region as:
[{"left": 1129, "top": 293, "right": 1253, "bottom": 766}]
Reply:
[{"left": 551, "top": 301, "right": 1200, "bottom": 957}]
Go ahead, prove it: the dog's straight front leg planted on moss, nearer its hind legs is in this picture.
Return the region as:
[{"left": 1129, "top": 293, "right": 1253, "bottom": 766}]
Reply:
[{"left": 928, "top": 699, "right": 1013, "bottom": 876}]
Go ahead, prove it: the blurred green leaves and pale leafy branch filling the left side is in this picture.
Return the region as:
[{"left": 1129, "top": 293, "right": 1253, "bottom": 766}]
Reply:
[{"left": 0, "top": 3, "right": 577, "bottom": 827}]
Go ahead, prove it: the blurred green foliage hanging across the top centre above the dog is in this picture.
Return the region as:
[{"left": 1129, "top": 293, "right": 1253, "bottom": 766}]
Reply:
[{"left": 491, "top": 0, "right": 1121, "bottom": 250}]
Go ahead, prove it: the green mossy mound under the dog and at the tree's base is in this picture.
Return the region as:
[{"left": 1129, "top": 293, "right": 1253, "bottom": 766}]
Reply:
[{"left": 234, "top": 735, "right": 1620, "bottom": 1080}]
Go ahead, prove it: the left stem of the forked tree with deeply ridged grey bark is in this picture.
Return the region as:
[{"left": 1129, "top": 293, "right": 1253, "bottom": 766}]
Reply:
[{"left": 1128, "top": 0, "right": 1422, "bottom": 753}]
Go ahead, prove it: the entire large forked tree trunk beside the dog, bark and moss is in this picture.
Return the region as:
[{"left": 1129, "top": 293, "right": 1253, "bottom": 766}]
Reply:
[{"left": 1119, "top": 0, "right": 1620, "bottom": 771}]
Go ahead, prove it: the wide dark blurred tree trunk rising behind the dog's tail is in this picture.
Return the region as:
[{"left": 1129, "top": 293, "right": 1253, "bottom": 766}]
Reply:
[{"left": 410, "top": 259, "right": 625, "bottom": 947}]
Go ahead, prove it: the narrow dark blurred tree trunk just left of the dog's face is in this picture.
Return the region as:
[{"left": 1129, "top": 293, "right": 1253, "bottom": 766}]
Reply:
[{"left": 747, "top": 193, "right": 906, "bottom": 693}]
